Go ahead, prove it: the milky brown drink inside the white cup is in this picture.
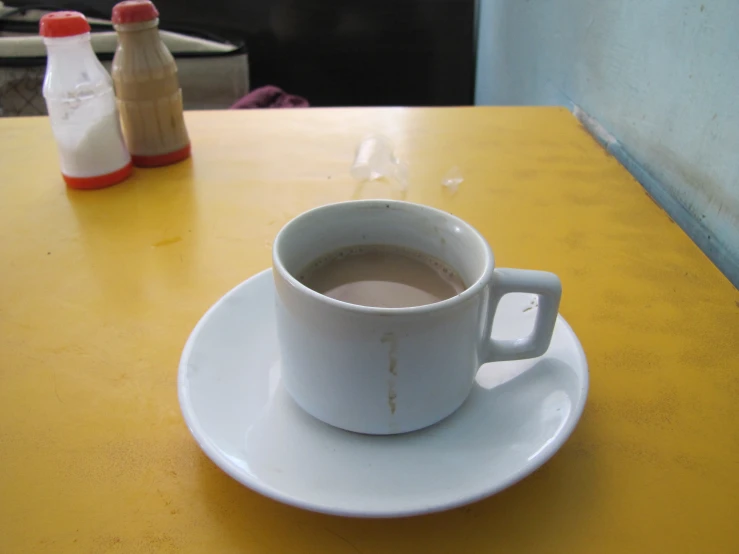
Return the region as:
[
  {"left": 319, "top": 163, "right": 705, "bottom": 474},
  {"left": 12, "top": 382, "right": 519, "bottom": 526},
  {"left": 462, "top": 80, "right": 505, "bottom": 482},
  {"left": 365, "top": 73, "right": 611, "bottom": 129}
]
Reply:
[{"left": 299, "top": 245, "right": 466, "bottom": 308}]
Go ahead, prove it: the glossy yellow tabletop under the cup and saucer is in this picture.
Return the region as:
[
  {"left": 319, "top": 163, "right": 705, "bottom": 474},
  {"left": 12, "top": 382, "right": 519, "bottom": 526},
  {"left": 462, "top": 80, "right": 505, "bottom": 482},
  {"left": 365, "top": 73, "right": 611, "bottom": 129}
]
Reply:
[{"left": 0, "top": 108, "right": 739, "bottom": 554}]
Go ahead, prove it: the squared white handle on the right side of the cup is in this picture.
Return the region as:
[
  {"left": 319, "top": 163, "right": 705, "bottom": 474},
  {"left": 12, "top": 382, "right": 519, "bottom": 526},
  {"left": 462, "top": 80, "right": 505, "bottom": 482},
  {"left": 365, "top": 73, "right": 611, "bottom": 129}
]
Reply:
[{"left": 481, "top": 269, "right": 562, "bottom": 363}]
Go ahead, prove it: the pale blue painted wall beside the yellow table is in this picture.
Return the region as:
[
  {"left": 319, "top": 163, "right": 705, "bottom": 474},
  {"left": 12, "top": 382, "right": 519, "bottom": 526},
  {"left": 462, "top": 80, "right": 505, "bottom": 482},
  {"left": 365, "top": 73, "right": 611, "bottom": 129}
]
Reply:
[{"left": 475, "top": 0, "right": 739, "bottom": 285}]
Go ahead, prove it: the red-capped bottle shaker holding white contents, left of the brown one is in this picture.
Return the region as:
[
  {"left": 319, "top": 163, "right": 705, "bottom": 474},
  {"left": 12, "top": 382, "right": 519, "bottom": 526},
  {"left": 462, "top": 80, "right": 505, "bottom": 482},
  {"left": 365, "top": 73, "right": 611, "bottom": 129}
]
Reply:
[{"left": 39, "top": 11, "right": 132, "bottom": 189}]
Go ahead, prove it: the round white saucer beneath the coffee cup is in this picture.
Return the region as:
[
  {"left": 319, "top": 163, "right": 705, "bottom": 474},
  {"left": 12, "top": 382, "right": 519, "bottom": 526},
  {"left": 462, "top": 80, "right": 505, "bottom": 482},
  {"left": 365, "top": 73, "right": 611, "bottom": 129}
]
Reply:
[{"left": 178, "top": 270, "right": 588, "bottom": 517}]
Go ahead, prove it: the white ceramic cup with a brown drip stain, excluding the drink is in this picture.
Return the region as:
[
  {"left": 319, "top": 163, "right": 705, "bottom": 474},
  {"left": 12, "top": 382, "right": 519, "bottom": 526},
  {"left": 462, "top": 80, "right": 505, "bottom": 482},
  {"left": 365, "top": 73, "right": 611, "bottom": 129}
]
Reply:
[{"left": 272, "top": 200, "right": 562, "bottom": 435}]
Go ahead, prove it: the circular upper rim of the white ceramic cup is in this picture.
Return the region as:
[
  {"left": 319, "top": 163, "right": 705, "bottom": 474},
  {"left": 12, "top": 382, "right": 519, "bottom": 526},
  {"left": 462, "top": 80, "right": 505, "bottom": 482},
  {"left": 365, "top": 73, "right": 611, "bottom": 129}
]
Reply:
[{"left": 272, "top": 199, "right": 495, "bottom": 316}]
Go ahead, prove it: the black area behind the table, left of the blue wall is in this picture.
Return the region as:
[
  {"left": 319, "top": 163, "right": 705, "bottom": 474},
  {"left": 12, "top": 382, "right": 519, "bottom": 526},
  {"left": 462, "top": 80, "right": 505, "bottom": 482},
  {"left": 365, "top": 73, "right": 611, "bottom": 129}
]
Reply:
[{"left": 8, "top": 0, "right": 475, "bottom": 106}]
